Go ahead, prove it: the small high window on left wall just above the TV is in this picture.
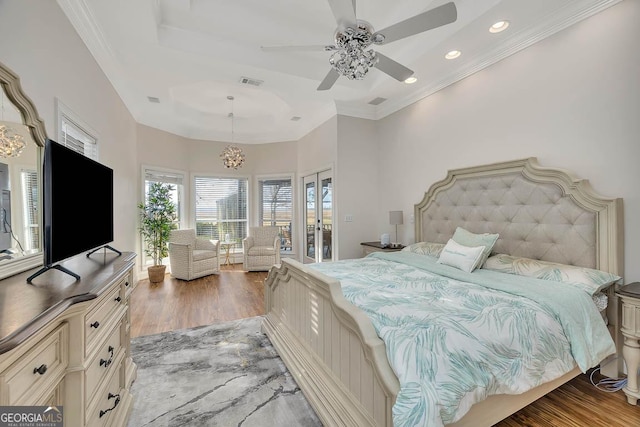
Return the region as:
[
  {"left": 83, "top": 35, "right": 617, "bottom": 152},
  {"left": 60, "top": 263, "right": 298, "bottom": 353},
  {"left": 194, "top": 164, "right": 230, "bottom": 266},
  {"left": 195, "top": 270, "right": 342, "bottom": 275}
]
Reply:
[{"left": 56, "top": 99, "right": 98, "bottom": 160}]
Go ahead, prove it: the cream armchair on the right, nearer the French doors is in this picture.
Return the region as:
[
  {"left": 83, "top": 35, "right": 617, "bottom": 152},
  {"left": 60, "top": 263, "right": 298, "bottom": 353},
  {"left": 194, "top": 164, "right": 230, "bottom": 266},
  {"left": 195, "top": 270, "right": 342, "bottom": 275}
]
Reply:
[{"left": 242, "top": 227, "right": 280, "bottom": 271}]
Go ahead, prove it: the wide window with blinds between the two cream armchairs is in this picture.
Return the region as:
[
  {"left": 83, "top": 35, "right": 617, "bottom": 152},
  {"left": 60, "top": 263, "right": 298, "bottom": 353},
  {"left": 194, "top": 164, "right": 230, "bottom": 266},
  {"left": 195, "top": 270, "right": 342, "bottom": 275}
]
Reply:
[{"left": 195, "top": 176, "right": 248, "bottom": 249}]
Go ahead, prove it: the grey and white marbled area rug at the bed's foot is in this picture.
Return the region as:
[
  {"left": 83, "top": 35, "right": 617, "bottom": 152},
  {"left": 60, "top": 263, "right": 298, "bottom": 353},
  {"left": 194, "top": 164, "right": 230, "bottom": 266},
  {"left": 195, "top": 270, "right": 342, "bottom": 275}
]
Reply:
[{"left": 128, "top": 317, "right": 322, "bottom": 427}]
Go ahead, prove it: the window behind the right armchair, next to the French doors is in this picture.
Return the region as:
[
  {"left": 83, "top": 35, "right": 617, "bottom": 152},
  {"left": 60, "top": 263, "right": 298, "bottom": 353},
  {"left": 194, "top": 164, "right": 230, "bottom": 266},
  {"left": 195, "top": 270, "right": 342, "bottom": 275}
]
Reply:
[{"left": 258, "top": 178, "right": 293, "bottom": 253}]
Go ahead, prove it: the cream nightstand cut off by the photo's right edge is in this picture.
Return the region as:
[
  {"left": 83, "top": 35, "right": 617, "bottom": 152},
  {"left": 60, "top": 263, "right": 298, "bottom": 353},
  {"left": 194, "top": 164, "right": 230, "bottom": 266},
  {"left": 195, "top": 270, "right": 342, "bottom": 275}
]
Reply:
[{"left": 616, "top": 282, "right": 640, "bottom": 405}]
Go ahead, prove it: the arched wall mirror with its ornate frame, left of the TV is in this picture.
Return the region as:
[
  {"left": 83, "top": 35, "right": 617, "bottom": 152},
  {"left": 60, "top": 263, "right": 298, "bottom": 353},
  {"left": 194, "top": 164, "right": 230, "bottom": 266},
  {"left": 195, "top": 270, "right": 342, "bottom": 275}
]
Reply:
[{"left": 0, "top": 62, "right": 47, "bottom": 279}]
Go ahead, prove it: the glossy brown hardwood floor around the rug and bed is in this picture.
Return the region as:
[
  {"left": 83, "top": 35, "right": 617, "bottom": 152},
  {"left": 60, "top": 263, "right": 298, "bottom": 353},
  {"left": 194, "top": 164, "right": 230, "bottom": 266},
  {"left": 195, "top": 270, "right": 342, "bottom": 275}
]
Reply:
[{"left": 131, "top": 264, "right": 640, "bottom": 427}]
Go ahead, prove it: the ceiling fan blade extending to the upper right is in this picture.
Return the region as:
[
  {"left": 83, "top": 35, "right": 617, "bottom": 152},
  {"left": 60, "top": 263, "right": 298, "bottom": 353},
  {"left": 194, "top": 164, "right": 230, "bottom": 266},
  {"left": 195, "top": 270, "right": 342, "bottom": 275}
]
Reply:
[{"left": 374, "top": 2, "right": 458, "bottom": 44}]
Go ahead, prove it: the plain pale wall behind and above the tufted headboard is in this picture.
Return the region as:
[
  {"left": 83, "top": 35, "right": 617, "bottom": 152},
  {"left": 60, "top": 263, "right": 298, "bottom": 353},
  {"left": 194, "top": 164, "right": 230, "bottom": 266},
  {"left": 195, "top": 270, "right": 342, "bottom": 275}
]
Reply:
[{"left": 377, "top": 0, "right": 640, "bottom": 282}]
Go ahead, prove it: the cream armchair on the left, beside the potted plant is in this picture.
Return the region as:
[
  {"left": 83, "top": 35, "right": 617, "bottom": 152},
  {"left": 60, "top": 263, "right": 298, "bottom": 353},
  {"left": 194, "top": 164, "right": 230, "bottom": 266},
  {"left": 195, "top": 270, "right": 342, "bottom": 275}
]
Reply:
[{"left": 169, "top": 228, "right": 220, "bottom": 280}]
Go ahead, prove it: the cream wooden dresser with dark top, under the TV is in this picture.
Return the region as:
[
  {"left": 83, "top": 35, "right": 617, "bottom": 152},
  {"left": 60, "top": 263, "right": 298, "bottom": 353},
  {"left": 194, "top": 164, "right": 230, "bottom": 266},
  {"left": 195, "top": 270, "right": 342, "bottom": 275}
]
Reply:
[{"left": 0, "top": 251, "right": 136, "bottom": 427}]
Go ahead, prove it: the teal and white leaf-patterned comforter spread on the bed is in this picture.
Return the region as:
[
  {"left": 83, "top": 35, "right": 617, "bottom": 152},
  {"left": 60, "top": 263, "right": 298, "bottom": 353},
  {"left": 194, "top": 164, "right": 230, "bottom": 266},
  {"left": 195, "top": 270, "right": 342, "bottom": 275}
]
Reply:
[{"left": 310, "top": 252, "right": 615, "bottom": 427}]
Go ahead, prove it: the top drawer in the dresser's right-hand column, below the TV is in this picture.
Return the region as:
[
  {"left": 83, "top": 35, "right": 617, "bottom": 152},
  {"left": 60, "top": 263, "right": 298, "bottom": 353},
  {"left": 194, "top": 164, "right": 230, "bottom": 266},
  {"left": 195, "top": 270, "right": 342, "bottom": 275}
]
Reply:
[{"left": 84, "top": 286, "right": 126, "bottom": 357}]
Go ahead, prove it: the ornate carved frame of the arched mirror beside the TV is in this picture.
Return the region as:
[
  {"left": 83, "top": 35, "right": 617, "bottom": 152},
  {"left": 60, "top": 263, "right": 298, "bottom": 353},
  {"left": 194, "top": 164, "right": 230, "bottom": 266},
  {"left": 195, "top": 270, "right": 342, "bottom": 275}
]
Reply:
[{"left": 0, "top": 62, "right": 47, "bottom": 279}]
